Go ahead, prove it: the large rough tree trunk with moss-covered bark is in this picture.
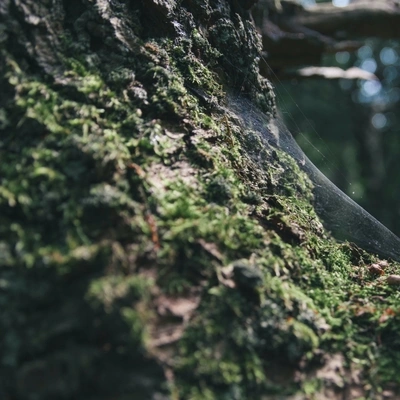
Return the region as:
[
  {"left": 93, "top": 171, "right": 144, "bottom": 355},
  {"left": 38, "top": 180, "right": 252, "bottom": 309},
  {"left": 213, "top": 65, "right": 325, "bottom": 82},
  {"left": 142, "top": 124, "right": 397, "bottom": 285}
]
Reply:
[{"left": 0, "top": 0, "right": 400, "bottom": 400}]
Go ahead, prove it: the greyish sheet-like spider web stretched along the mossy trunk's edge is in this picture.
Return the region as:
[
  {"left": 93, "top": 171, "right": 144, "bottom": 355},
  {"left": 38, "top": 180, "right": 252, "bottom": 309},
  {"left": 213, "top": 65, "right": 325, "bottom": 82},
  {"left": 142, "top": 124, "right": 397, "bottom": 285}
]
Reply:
[{"left": 223, "top": 94, "right": 400, "bottom": 262}]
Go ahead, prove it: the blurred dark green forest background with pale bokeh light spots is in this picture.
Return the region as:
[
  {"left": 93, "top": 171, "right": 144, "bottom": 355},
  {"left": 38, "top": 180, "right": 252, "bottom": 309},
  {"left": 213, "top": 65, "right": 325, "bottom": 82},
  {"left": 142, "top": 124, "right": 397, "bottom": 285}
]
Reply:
[{"left": 256, "top": 0, "right": 400, "bottom": 236}]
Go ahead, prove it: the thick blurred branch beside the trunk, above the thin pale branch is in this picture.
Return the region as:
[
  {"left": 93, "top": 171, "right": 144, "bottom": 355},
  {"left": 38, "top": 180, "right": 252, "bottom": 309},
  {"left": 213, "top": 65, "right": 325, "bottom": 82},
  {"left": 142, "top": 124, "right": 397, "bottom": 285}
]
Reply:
[{"left": 254, "top": 0, "right": 400, "bottom": 76}]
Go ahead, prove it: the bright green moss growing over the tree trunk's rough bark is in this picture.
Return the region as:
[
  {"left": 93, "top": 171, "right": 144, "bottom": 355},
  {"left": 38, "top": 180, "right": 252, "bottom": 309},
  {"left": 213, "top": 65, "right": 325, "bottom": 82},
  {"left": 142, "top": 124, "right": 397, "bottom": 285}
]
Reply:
[{"left": 0, "top": 2, "right": 400, "bottom": 400}]
